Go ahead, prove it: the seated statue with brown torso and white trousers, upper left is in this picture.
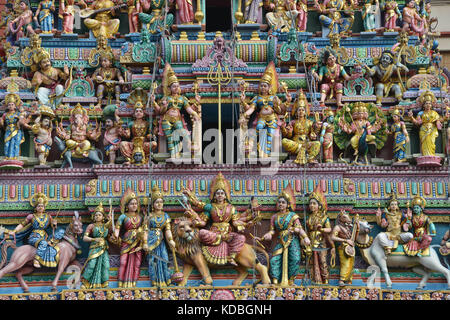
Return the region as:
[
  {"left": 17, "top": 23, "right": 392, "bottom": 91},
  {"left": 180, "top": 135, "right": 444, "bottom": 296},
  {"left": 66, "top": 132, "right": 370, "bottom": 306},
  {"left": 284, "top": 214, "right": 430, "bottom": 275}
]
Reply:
[{"left": 31, "top": 49, "right": 70, "bottom": 109}]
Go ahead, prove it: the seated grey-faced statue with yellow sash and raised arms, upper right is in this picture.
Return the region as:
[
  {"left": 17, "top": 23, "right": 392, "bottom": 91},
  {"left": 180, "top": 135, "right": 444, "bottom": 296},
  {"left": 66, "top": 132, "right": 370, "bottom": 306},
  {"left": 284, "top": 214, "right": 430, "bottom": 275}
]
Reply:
[{"left": 364, "top": 50, "right": 409, "bottom": 105}]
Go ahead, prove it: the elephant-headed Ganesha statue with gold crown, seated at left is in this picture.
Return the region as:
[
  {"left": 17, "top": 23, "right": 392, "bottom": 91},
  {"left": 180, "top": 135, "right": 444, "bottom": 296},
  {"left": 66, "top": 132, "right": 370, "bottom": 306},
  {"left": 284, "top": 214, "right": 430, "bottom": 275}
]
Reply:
[{"left": 55, "top": 103, "right": 103, "bottom": 168}]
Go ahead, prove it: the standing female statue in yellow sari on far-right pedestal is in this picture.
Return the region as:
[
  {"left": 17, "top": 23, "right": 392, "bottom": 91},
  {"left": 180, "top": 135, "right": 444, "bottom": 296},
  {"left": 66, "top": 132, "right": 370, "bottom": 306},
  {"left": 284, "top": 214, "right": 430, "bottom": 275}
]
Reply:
[{"left": 408, "top": 90, "right": 442, "bottom": 156}]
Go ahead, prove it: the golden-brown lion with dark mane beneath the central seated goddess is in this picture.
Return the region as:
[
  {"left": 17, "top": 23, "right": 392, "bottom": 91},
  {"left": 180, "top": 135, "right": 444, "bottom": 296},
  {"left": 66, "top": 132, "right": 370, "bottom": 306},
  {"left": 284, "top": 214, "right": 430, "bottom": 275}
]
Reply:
[{"left": 173, "top": 217, "right": 270, "bottom": 286}]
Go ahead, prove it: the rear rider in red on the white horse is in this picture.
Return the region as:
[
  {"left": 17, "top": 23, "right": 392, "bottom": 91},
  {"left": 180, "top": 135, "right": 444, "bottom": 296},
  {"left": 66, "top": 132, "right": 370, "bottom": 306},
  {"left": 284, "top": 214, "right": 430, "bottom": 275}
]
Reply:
[{"left": 403, "top": 195, "right": 436, "bottom": 257}]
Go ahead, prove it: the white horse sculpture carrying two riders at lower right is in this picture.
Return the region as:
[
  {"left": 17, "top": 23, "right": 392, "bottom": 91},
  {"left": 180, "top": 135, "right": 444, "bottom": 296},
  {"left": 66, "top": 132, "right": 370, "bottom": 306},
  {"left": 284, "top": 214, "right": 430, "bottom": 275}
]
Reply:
[{"left": 356, "top": 220, "right": 450, "bottom": 289}]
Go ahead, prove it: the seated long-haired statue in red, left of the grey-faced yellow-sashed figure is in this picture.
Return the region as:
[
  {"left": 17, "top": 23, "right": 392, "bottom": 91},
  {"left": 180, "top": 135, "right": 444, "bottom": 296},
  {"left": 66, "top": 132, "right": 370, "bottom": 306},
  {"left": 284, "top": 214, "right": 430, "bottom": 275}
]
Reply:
[{"left": 312, "top": 49, "right": 351, "bottom": 108}]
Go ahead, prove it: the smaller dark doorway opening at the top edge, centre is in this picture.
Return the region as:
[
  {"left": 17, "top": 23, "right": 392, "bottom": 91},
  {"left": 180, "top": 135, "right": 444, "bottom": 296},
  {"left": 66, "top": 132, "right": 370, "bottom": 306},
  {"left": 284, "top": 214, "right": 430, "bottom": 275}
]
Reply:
[{"left": 206, "top": 0, "right": 231, "bottom": 32}]
